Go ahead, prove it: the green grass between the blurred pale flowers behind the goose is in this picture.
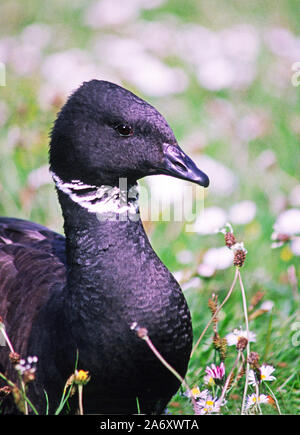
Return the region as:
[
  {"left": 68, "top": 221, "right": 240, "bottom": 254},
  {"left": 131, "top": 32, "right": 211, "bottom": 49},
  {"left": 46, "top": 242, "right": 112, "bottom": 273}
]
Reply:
[{"left": 0, "top": 0, "right": 300, "bottom": 415}]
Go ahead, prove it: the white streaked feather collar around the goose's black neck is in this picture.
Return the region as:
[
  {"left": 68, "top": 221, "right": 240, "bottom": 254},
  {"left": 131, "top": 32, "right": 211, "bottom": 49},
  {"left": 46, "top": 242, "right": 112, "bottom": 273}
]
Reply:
[{"left": 51, "top": 171, "right": 139, "bottom": 215}]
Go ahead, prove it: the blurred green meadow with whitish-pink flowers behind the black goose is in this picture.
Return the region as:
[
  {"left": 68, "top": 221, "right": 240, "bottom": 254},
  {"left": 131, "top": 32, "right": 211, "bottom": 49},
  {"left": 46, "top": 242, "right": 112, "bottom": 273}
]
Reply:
[{"left": 0, "top": 0, "right": 300, "bottom": 414}]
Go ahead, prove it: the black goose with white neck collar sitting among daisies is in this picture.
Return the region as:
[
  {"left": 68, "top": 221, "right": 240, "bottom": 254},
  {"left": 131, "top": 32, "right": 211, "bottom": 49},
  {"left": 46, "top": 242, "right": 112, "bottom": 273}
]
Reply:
[{"left": 0, "top": 80, "right": 209, "bottom": 414}]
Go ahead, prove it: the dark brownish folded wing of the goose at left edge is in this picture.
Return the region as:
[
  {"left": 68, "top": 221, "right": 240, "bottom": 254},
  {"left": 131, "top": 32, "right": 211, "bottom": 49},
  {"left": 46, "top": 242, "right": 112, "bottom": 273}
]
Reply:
[{"left": 0, "top": 217, "right": 66, "bottom": 379}]
